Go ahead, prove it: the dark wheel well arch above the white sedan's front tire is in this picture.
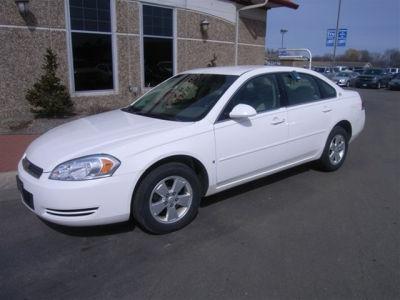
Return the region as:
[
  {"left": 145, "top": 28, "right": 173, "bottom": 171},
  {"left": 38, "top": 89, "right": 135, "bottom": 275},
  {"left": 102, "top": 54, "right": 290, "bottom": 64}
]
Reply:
[{"left": 135, "top": 155, "right": 209, "bottom": 195}]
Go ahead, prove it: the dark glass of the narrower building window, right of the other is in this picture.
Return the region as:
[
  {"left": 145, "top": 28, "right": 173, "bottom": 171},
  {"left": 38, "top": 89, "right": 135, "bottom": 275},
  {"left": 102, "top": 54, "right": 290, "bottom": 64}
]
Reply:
[{"left": 142, "top": 5, "right": 174, "bottom": 87}]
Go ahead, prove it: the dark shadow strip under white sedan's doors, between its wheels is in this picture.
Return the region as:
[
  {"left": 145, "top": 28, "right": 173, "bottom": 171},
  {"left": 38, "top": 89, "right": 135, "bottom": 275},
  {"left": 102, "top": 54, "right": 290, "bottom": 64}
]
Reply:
[{"left": 200, "top": 162, "right": 316, "bottom": 207}]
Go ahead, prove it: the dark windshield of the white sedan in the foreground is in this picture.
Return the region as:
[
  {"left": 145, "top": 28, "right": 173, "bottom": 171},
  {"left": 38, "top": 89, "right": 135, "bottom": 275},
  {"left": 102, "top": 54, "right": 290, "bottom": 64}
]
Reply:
[{"left": 123, "top": 74, "right": 238, "bottom": 122}]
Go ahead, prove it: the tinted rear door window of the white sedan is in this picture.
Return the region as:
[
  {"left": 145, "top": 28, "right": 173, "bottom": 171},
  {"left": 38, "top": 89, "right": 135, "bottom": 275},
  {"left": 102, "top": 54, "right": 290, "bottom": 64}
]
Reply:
[{"left": 281, "top": 72, "right": 323, "bottom": 106}]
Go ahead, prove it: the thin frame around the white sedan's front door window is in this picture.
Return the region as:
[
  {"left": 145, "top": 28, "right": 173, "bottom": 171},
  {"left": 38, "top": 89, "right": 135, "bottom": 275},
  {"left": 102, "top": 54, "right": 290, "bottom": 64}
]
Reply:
[{"left": 214, "top": 72, "right": 287, "bottom": 124}]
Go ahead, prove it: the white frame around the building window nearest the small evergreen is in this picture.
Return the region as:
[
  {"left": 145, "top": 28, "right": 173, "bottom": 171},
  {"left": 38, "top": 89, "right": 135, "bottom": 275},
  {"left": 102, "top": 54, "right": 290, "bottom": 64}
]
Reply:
[{"left": 64, "top": 0, "right": 119, "bottom": 97}]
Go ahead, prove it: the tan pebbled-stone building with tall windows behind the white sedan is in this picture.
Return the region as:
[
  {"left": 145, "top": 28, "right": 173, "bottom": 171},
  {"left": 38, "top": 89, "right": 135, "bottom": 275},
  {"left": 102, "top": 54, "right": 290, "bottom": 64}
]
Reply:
[{"left": 0, "top": 0, "right": 297, "bottom": 120}]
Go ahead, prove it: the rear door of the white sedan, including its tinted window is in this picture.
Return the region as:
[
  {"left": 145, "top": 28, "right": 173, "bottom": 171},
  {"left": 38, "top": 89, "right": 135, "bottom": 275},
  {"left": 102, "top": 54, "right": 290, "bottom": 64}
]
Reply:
[{"left": 281, "top": 72, "right": 336, "bottom": 162}]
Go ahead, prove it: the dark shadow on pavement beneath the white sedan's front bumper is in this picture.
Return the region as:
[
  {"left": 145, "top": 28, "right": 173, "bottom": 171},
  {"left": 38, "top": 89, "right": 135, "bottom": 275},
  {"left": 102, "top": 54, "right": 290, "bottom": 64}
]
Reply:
[{"left": 40, "top": 219, "right": 137, "bottom": 237}]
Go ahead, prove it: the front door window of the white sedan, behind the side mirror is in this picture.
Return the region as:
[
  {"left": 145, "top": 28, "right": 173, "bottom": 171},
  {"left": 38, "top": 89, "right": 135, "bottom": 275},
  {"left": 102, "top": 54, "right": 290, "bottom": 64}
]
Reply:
[{"left": 218, "top": 74, "right": 280, "bottom": 121}]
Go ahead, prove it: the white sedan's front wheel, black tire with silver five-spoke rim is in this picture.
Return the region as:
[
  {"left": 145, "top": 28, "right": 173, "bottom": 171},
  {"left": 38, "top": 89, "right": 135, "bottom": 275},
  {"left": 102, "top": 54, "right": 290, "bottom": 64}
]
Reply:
[{"left": 132, "top": 162, "right": 201, "bottom": 234}]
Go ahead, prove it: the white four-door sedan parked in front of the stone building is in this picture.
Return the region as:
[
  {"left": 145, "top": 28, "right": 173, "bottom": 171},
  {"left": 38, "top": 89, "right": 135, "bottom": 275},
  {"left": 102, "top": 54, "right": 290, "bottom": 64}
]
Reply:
[{"left": 17, "top": 66, "right": 365, "bottom": 233}]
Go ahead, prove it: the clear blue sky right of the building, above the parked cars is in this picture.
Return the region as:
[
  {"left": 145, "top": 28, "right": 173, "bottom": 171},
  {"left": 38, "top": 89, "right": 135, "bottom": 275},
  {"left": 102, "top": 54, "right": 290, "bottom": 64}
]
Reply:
[{"left": 266, "top": 0, "right": 400, "bottom": 55}]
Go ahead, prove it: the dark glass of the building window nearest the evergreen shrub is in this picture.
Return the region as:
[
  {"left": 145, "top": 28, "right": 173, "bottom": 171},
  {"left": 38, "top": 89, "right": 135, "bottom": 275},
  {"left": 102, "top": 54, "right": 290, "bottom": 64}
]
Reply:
[{"left": 69, "top": 0, "right": 114, "bottom": 92}]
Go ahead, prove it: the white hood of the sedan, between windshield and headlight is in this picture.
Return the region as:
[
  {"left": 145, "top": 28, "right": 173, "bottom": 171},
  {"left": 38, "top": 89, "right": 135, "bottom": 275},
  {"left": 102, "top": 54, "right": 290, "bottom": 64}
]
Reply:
[{"left": 26, "top": 110, "right": 192, "bottom": 172}]
